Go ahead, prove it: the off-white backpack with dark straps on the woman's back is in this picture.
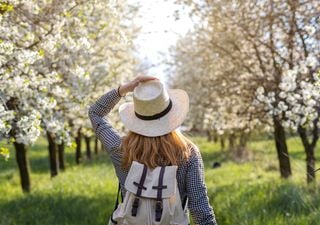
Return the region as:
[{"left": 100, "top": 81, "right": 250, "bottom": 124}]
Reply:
[{"left": 109, "top": 161, "right": 188, "bottom": 225}]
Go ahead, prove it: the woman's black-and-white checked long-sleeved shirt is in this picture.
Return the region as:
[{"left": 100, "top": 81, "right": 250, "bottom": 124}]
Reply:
[{"left": 89, "top": 89, "right": 217, "bottom": 225}]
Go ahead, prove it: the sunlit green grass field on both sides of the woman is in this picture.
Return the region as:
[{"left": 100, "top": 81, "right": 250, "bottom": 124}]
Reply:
[{"left": 0, "top": 135, "right": 320, "bottom": 225}]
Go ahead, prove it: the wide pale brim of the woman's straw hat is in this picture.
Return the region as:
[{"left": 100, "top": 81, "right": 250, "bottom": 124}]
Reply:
[{"left": 119, "top": 89, "right": 189, "bottom": 137}]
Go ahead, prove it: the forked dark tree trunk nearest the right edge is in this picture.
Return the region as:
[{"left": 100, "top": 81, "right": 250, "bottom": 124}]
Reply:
[{"left": 298, "top": 125, "right": 319, "bottom": 183}]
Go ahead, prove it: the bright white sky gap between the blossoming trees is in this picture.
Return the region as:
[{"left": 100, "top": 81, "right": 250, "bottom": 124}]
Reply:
[{"left": 131, "top": 0, "right": 192, "bottom": 78}]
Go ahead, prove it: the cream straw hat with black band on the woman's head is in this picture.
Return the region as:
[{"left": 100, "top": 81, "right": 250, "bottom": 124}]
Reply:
[{"left": 119, "top": 80, "right": 189, "bottom": 137}]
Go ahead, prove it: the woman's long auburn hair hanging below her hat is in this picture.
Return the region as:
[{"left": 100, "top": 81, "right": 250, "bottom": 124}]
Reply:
[{"left": 121, "top": 131, "right": 194, "bottom": 170}]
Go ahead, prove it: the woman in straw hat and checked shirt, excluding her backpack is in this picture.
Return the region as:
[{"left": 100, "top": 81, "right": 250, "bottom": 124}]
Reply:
[{"left": 89, "top": 76, "right": 217, "bottom": 225}]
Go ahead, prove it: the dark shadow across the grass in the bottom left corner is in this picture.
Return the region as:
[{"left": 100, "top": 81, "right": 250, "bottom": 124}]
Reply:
[{"left": 0, "top": 194, "right": 114, "bottom": 225}]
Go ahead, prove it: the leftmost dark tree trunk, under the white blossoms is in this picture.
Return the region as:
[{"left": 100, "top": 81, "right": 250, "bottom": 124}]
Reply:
[{"left": 13, "top": 142, "right": 31, "bottom": 193}]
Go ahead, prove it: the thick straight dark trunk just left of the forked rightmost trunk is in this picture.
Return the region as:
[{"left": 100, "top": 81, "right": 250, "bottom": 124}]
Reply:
[{"left": 273, "top": 118, "right": 292, "bottom": 178}]
